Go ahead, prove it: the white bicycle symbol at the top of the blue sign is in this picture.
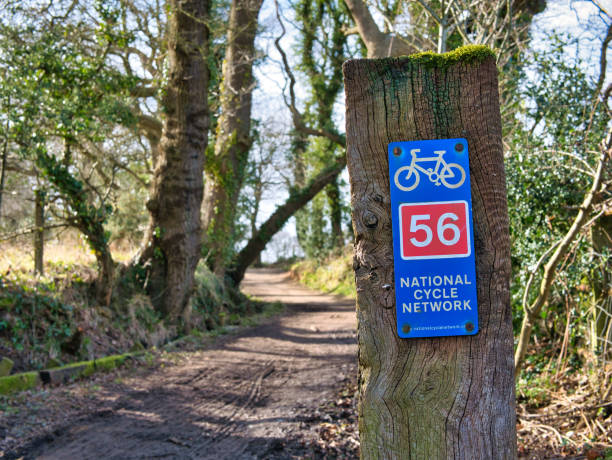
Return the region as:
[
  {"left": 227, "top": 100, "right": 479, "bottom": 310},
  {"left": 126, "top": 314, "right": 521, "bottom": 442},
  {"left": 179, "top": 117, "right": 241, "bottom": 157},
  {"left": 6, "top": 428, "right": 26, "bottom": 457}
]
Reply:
[{"left": 393, "top": 149, "right": 465, "bottom": 192}]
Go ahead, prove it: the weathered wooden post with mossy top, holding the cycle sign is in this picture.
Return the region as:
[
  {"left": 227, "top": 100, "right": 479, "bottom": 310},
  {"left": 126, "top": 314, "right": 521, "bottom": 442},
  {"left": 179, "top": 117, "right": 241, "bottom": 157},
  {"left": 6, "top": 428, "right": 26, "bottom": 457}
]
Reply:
[{"left": 344, "top": 46, "right": 516, "bottom": 460}]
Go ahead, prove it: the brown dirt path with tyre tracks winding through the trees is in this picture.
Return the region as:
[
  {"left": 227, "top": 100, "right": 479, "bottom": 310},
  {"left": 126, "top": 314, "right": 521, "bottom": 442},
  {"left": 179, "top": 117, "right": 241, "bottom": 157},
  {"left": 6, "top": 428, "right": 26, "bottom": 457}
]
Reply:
[{"left": 7, "top": 269, "right": 356, "bottom": 459}]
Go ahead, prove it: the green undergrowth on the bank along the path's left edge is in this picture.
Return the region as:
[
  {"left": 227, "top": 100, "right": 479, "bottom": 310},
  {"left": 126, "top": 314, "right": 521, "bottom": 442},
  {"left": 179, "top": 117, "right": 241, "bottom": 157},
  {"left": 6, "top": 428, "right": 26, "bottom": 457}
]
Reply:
[{"left": 0, "top": 256, "right": 282, "bottom": 380}]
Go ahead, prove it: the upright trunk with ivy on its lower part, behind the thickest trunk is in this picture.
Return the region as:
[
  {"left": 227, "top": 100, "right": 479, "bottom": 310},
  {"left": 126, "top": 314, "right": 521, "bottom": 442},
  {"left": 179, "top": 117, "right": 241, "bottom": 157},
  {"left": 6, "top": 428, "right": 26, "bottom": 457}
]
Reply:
[{"left": 202, "top": 0, "right": 263, "bottom": 277}]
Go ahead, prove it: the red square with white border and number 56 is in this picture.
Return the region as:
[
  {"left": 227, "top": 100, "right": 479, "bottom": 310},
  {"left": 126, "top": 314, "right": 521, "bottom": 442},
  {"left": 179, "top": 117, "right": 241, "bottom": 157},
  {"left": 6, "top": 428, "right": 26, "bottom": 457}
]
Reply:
[{"left": 399, "top": 201, "right": 471, "bottom": 260}]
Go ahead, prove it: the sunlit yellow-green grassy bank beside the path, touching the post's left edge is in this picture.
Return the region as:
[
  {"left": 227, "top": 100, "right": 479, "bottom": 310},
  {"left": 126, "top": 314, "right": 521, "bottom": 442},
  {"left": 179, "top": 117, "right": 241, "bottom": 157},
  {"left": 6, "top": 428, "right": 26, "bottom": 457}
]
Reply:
[{"left": 291, "top": 245, "right": 356, "bottom": 299}]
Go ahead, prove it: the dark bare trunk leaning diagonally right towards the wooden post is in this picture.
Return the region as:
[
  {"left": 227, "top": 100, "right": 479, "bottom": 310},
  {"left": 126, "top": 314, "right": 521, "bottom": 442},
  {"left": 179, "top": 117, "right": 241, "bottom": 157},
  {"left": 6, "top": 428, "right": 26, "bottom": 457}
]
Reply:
[{"left": 226, "top": 155, "right": 346, "bottom": 286}]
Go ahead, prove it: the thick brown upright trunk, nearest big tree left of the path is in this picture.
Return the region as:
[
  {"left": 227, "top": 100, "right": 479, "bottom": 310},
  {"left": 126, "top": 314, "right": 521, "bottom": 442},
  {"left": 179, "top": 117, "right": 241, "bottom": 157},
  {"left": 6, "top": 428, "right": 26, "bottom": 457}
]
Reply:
[{"left": 136, "top": 0, "right": 210, "bottom": 320}]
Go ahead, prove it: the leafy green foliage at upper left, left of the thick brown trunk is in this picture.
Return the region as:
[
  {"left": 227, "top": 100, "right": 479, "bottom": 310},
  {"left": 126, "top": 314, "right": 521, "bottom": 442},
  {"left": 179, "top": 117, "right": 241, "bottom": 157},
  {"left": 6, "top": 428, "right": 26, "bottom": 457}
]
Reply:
[{"left": 0, "top": 1, "right": 137, "bottom": 270}]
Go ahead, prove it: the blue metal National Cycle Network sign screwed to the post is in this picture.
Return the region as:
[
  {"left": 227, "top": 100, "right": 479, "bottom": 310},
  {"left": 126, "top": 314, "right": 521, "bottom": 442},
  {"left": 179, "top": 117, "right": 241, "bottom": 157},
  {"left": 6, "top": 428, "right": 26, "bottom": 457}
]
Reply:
[{"left": 389, "top": 138, "right": 478, "bottom": 338}]
